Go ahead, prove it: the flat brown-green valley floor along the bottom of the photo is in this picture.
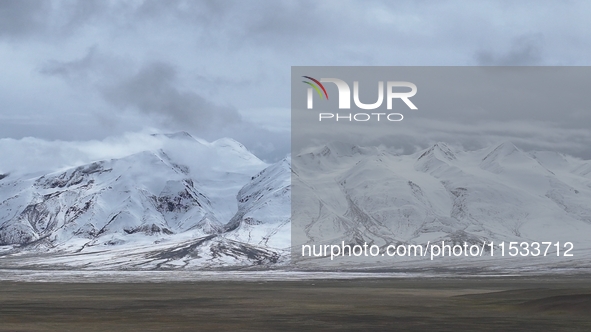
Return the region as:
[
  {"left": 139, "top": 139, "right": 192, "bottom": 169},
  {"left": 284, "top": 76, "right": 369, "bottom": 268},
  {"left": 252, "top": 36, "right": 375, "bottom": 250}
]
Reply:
[{"left": 0, "top": 276, "right": 591, "bottom": 331}]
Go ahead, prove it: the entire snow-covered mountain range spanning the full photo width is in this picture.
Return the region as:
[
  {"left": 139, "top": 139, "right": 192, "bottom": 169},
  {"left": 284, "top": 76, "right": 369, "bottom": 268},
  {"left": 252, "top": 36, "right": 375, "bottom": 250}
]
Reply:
[{"left": 0, "top": 132, "right": 591, "bottom": 270}]
